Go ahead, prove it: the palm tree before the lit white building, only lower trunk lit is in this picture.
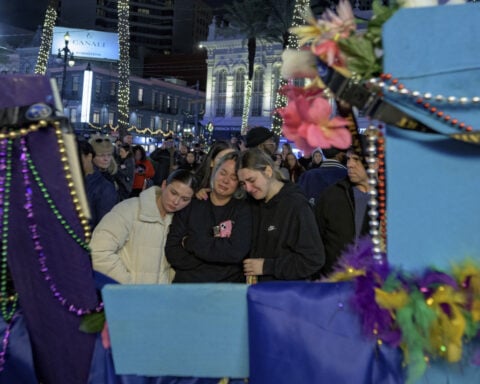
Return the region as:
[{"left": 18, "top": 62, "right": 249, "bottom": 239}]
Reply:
[{"left": 225, "top": 0, "right": 271, "bottom": 135}]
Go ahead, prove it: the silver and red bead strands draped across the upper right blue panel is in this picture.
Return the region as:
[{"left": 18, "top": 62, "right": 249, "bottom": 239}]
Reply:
[{"left": 369, "top": 74, "right": 480, "bottom": 132}]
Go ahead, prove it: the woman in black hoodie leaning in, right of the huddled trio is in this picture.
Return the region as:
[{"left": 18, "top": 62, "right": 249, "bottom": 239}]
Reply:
[{"left": 237, "top": 148, "right": 325, "bottom": 282}]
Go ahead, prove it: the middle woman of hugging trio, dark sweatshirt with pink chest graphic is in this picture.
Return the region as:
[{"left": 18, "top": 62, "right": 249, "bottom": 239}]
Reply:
[{"left": 165, "top": 152, "right": 252, "bottom": 283}]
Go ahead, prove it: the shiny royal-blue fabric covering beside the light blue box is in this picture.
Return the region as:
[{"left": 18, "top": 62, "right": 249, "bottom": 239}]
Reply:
[{"left": 248, "top": 282, "right": 404, "bottom": 384}]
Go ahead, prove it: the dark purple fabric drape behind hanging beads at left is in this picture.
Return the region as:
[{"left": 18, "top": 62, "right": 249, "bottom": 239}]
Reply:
[{"left": 8, "top": 128, "right": 97, "bottom": 384}]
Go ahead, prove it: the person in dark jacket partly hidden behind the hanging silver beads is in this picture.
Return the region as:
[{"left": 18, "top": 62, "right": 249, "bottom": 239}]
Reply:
[{"left": 315, "top": 151, "right": 369, "bottom": 276}]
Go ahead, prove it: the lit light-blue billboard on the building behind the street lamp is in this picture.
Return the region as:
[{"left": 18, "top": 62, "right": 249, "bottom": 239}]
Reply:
[{"left": 52, "top": 27, "right": 119, "bottom": 60}]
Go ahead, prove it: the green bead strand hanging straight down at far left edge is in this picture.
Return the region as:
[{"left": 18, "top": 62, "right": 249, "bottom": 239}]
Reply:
[{"left": 0, "top": 139, "right": 18, "bottom": 323}]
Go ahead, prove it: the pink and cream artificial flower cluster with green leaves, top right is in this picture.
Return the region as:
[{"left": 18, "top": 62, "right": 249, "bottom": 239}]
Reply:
[{"left": 277, "top": 0, "right": 464, "bottom": 153}]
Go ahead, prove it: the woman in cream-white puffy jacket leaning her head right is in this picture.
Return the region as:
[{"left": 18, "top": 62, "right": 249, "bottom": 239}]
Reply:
[{"left": 90, "top": 170, "right": 197, "bottom": 284}]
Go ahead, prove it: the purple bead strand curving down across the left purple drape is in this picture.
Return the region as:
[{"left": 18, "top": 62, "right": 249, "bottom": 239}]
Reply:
[{"left": 20, "top": 137, "right": 103, "bottom": 316}]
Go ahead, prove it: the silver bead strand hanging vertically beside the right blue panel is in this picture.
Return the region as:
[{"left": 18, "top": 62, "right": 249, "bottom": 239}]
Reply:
[{"left": 365, "top": 124, "right": 383, "bottom": 263}]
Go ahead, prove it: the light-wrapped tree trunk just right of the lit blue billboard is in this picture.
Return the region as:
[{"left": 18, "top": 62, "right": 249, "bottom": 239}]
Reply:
[{"left": 117, "top": 0, "right": 130, "bottom": 137}]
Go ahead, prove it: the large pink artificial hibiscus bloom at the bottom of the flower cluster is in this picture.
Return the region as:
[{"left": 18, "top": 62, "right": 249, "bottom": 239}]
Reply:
[{"left": 278, "top": 86, "right": 352, "bottom": 153}]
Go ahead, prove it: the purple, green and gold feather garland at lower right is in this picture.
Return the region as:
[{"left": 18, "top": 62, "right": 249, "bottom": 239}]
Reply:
[{"left": 328, "top": 239, "right": 480, "bottom": 382}]
